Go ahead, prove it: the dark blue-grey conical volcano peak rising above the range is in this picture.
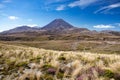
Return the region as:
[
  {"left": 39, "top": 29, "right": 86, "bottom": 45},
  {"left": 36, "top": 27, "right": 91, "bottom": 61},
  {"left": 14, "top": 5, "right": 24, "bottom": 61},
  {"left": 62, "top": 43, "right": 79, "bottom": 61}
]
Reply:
[{"left": 42, "top": 19, "right": 74, "bottom": 30}]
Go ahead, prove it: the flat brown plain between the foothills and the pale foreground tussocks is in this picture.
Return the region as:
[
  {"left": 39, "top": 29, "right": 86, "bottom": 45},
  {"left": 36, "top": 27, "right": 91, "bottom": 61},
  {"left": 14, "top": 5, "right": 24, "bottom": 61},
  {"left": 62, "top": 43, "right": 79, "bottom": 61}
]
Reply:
[{"left": 1, "top": 40, "right": 120, "bottom": 54}]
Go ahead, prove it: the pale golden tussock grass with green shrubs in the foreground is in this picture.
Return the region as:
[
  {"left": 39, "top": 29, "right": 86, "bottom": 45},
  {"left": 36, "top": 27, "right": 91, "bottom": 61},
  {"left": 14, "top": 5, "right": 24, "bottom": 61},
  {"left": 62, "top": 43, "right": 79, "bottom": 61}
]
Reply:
[{"left": 0, "top": 43, "right": 120, "bottom": 80}]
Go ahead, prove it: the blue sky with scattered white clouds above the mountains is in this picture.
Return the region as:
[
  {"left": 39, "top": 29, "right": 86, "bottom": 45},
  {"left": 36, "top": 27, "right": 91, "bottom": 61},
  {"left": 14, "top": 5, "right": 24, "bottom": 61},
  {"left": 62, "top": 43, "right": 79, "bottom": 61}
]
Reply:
[{"left": 0, "top": 0, "right": 120, "bottom": 31}]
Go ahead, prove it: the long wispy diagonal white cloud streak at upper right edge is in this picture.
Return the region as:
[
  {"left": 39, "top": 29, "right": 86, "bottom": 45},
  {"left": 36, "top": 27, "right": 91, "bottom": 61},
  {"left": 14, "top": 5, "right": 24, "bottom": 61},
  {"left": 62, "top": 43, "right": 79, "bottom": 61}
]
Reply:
[{"left": 94, "top": 3, "right": 120, "bottom": 13}]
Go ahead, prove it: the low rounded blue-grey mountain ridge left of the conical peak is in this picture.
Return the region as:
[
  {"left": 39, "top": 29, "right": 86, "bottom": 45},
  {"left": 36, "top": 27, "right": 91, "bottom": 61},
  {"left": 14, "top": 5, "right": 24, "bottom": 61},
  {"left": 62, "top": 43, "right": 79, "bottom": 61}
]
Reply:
[{"left": 2, "top": 26, "right": 39, "bottom": 34}]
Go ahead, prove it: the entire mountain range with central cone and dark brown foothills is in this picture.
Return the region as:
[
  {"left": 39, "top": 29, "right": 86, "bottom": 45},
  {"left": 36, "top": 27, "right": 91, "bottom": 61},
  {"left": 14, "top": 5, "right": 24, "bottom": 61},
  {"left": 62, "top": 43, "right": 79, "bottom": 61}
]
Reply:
[{"left": 0, "top": 19, "right": 120, "bottom": 40}]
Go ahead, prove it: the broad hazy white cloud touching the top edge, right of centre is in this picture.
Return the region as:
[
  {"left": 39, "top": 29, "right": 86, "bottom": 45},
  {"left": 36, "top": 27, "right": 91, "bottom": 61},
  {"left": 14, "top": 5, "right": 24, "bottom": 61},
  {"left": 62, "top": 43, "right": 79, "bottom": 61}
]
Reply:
[{"left": 68, "top": 0, "right": 99, "bottom": 8}]
